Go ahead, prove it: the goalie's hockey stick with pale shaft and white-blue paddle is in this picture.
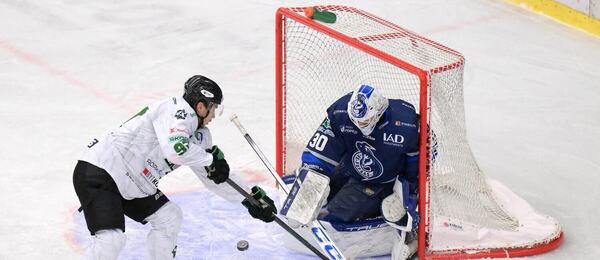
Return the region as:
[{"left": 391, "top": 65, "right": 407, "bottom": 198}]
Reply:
[{"left": 229, "top": 114, "right": 346, "bottom": 260}]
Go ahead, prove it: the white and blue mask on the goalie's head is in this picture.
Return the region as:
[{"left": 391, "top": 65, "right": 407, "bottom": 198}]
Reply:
[{"left": 348, "top": 85, "right": 388, "bottom": 135}]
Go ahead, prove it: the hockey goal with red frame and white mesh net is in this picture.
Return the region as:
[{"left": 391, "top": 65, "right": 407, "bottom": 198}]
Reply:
[{"left": 275, "top": 5, "right": 563, "bottom": 259}]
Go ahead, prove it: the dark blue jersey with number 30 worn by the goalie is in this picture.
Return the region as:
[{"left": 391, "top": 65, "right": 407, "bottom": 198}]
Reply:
[{"left": 302, "top": 93, "right": 419, "bottom": 184}]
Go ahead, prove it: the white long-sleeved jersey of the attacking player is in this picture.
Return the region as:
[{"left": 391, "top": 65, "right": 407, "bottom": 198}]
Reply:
[{"left": 81, "top": 97, "right": 213, "bottom": 200}]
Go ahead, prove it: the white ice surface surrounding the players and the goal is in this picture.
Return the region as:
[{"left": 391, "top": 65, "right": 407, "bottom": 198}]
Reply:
[{"left": 0, "top": 0, "right": 600, "bottom": 259}]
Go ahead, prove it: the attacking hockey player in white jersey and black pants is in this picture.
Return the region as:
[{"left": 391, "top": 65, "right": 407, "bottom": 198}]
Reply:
[{"left": 73, "top": 75, "right": 275, "bottom": 259}]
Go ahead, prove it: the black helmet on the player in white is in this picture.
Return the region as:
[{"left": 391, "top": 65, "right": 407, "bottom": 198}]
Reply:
[{"left": 183, "top": 75, "right": 223, "bottom": 110}]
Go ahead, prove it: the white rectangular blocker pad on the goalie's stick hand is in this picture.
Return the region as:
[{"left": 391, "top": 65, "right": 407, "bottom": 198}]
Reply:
[{"left": 280, "top": 168, "right": 329, "bottom": 226}]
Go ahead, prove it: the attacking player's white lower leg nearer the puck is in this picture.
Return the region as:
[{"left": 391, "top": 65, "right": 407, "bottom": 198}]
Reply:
[{"left": 146, "top": 201, "right": 183, "bottom": 259}]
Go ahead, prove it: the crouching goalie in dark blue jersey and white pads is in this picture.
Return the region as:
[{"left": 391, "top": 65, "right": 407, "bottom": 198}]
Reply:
[{"left": 281, "top": 85, "right": 419, "bottom": 259}]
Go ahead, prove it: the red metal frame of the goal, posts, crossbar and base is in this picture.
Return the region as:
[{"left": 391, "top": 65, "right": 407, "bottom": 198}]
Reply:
[{"left": 275, "top": 6, "right": 564, "bottom": 259}]
